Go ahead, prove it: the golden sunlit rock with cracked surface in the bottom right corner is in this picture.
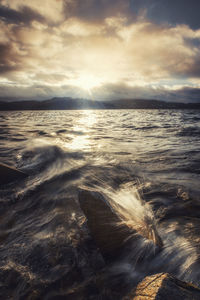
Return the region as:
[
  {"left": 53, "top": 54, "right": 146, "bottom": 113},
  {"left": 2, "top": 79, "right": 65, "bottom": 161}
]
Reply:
[{"left": 123, "top": 273, "right": 200, "bottom": 300}]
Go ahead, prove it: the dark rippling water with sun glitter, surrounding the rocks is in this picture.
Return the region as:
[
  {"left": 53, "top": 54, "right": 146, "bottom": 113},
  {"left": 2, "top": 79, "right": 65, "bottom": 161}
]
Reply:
[{"left": 0, "top": 110, "right": 200, "bottom": 299}]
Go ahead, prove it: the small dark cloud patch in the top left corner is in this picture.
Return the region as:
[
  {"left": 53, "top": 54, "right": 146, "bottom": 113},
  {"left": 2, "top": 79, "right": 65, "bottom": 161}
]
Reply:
[{"left": 0, "top": 5, "right": 45, "bottom": 24}]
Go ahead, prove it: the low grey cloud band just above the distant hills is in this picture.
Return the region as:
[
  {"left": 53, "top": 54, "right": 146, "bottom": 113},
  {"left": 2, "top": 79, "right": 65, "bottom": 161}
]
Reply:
[{"left": 0, "top": 78, "right": 200, "bottom": 103}]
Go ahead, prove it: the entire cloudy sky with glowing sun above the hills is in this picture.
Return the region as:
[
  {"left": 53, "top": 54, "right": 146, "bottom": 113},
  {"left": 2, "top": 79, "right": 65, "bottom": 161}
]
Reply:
[{"left": 0, "top": 0, "right": 200, "bottom": 102}]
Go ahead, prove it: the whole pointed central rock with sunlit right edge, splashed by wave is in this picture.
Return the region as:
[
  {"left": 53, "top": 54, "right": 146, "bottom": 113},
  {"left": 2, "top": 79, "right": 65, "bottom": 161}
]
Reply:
[{"left": 79, "top": 190, "right": 163, "bottom": 259}]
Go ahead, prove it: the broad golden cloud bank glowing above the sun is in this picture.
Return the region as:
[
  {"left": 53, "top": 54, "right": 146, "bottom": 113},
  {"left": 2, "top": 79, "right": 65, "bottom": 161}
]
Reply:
[{"left": 0, "top": 0, "right": 200, "bottom": 98}]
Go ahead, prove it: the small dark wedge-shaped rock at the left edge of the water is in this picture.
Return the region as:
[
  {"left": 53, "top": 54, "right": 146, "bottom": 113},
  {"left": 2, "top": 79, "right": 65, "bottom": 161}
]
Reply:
[{"left": 0, "top": 163, "right": 28, "bottom": 185}]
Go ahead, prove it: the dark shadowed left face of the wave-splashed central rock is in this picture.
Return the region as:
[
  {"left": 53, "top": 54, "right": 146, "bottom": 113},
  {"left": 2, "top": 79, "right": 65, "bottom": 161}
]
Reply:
[{"left": 79, "top": 191, "right": 133, "bottom": 258}]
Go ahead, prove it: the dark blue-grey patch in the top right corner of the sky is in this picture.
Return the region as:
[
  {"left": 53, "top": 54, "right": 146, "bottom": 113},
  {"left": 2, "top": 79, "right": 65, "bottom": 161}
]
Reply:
[{"left": 130, "top": 0, "right": 200, "bottom": 29}]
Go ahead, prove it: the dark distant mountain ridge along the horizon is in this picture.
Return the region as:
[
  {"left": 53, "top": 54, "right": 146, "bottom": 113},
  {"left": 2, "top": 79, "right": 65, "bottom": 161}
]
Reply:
[{"left": 0, "top": 97, "right": 200, "bottom": 110}]
